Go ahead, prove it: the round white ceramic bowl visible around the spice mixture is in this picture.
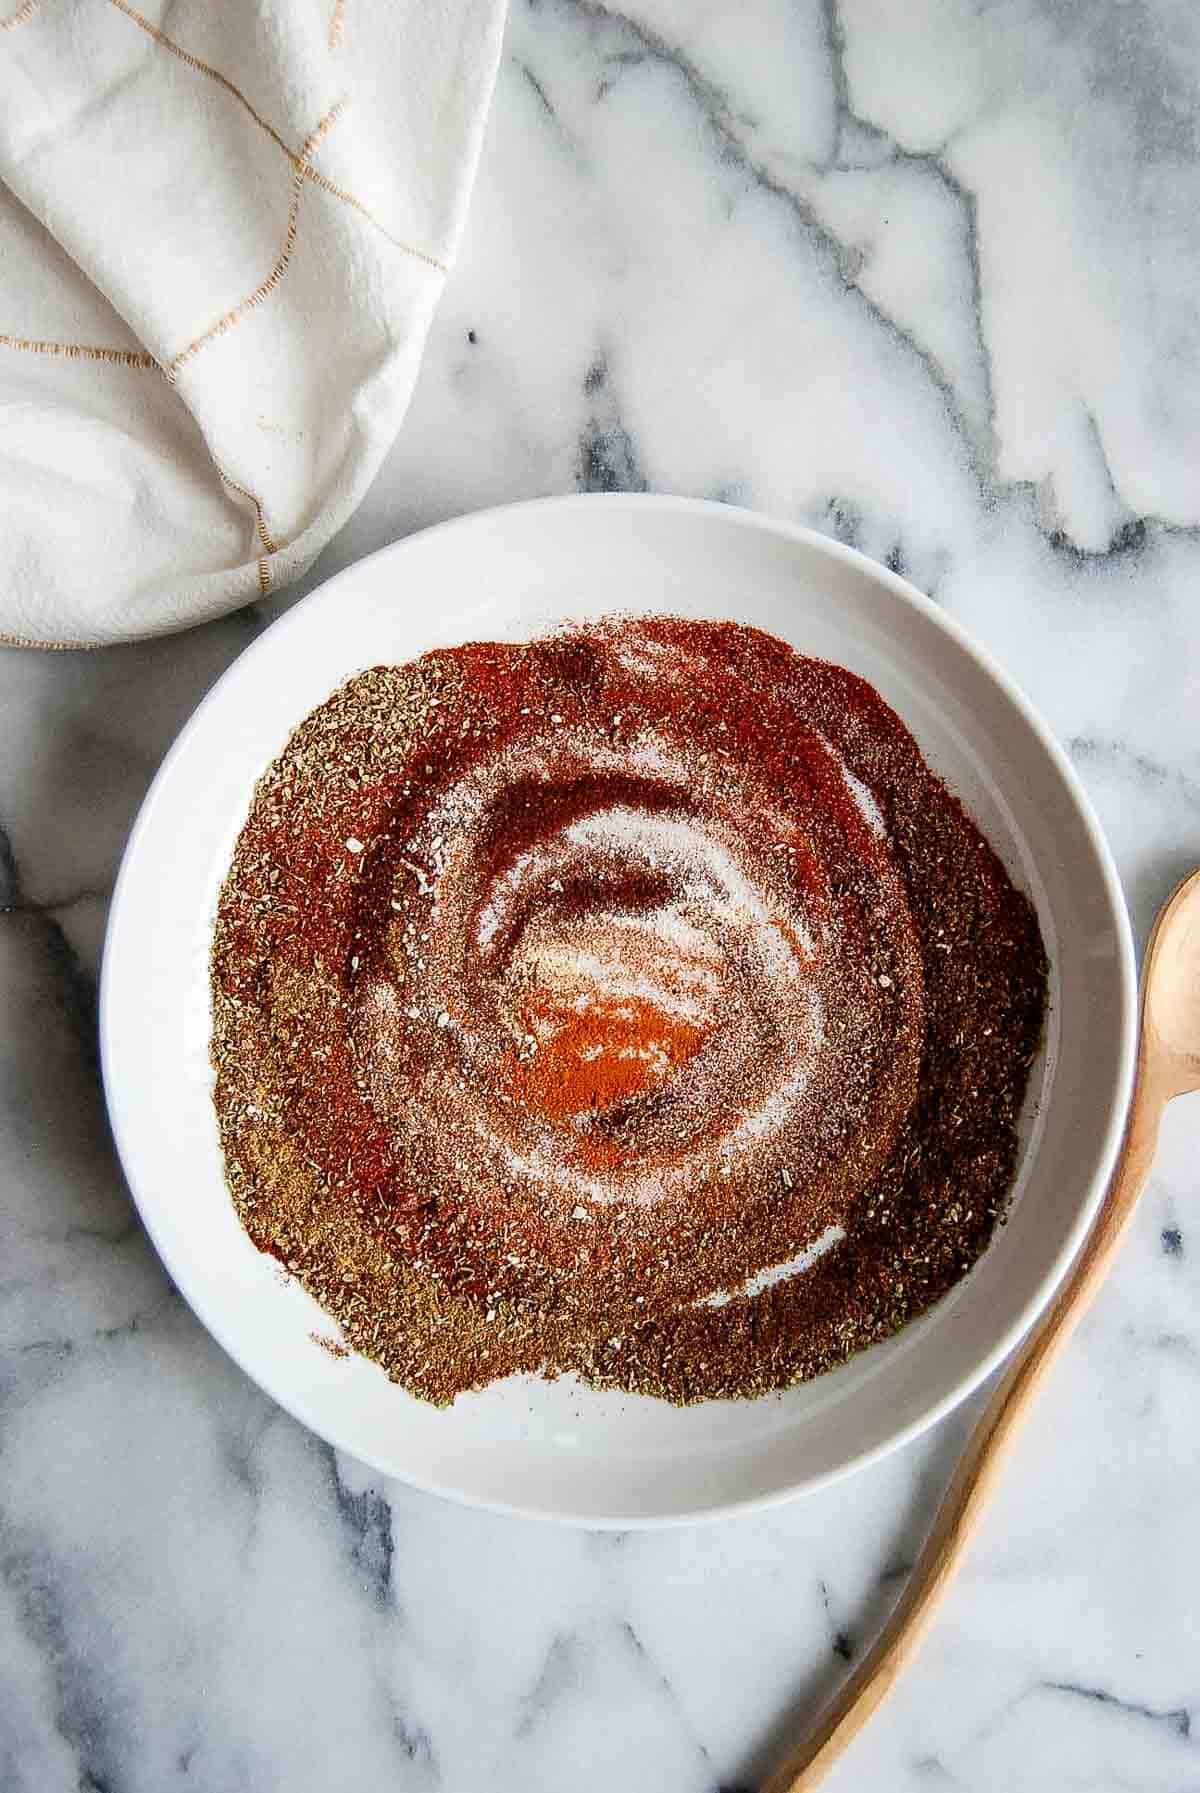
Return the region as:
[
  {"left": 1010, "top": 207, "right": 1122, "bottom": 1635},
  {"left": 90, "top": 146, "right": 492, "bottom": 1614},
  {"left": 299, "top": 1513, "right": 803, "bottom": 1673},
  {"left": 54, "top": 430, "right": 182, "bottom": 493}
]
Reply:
[{"left": 100, "top": 497, "right": 1135, "bottom": 1526}]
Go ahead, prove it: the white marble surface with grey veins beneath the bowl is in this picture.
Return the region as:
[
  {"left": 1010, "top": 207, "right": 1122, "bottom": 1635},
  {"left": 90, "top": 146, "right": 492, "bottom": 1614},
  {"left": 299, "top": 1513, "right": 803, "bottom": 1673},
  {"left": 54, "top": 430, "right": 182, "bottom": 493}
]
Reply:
[{"left": 0, "top": 0, "right": 1200, "bottom": 1793}]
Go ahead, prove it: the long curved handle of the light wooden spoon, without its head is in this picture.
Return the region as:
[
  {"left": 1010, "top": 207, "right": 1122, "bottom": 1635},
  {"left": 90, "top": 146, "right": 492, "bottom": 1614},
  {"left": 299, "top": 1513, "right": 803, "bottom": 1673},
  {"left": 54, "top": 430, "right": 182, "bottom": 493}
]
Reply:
[{"left": 762, "top": 1054, "right": 1166, "bottom": 1793}]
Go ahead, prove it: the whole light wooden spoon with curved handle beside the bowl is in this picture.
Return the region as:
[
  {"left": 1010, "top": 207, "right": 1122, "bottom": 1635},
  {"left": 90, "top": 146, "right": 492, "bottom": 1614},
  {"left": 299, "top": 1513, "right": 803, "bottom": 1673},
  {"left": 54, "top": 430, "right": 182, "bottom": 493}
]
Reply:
[{"left": 762, "top": 871, "right": 1200, "bottom": 1793}]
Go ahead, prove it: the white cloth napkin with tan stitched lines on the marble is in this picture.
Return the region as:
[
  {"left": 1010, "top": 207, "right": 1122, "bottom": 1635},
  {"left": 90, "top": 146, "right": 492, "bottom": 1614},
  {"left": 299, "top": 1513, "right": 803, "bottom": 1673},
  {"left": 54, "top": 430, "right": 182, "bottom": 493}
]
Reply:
[{"left": 0, "top": 0, "right": 502, "bottom": 647}]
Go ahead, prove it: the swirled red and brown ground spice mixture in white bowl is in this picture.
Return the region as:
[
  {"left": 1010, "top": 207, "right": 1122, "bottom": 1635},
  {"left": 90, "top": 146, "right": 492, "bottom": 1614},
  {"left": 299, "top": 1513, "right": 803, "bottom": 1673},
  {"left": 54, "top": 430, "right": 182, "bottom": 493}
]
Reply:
[{"left": 212, "top": 617, "right": 1046, "bottom": 1402}]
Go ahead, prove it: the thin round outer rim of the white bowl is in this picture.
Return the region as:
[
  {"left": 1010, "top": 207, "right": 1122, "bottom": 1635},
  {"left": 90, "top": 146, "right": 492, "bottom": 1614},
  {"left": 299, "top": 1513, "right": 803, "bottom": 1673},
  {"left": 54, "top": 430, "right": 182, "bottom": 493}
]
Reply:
[{"left": 99, "top": 493, "right": 1137, "bottom": 1531}]
